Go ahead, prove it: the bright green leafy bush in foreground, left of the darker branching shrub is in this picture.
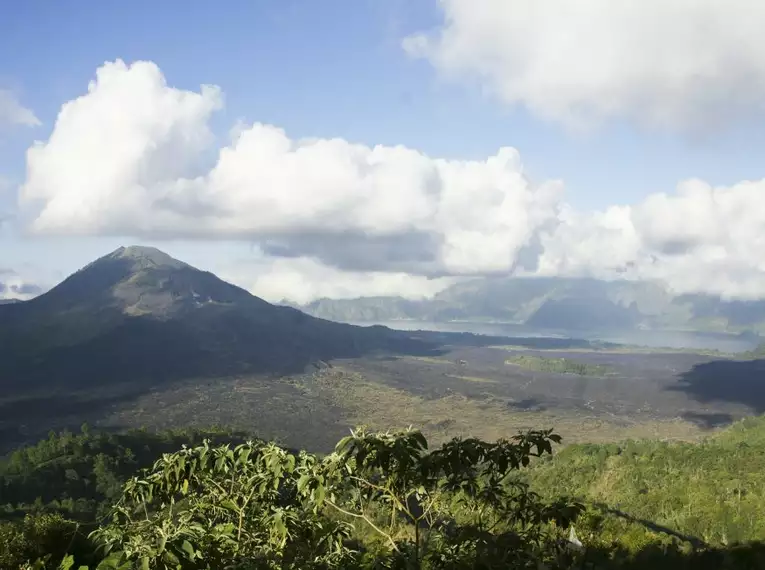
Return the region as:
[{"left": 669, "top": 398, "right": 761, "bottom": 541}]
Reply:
[{"left": 93, "top": 441, "right": 349, "bottom": 569}]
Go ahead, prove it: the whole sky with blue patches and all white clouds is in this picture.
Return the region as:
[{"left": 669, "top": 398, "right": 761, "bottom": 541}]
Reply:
[{"left": 0, "top": 0, "right": 765, "bottom": 302}]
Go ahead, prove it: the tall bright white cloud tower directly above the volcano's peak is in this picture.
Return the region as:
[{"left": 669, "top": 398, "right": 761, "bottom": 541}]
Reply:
[{"left": 21, "top": 61, "right": 221, "bottom": 234}]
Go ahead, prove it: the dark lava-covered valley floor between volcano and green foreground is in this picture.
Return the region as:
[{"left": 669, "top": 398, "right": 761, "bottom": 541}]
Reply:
[{"left": 0, "top": 346, "right": 765, "bottom": 451}]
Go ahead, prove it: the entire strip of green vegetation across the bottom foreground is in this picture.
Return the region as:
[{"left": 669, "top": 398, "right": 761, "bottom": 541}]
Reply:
[{"left": 0, "top": 418, "right": 765, "bottom": 570}]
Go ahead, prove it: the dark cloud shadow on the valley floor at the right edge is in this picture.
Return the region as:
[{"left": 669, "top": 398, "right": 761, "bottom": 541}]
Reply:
[{"left": 669, "top": 360, "right": 765, "bottom": 414}]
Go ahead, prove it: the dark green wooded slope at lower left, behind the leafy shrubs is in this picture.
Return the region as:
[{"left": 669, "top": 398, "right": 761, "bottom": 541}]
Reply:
[{"left": 0, "top": 425, "right": 251, "bottom": 570}]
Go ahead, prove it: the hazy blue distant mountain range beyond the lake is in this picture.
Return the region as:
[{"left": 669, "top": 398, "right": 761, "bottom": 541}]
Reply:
[{"left": 295, "top": 277, "right": 765, "bottom": 333}]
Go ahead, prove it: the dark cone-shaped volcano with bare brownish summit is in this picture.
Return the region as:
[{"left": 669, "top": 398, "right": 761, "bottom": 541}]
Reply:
[{"left": 0, "top": 247, "right": 424, "bottom": 395}]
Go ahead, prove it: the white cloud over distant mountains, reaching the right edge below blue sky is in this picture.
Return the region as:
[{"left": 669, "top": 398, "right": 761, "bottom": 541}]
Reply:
[{"left": 539, "top": 180, "right": 765, "bottom": 299}]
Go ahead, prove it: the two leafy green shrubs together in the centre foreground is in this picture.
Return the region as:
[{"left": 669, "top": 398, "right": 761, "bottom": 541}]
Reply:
[{"left": 4, "top": 430, "right": 581, "bottom": 569}]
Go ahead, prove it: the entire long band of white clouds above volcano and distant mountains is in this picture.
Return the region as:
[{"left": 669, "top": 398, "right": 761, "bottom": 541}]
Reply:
[{"left": 19, "top": 60, "right": 765, "bottom": 299}]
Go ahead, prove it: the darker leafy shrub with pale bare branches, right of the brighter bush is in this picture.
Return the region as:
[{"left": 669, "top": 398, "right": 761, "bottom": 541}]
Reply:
[{"left": 324, "top": 424, "right": 583, "bottom": 568}]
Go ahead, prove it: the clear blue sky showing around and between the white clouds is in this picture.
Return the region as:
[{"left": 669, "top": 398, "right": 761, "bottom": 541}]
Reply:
[{"left": 0, "top": 0, "right": 765, "bottom": 302}]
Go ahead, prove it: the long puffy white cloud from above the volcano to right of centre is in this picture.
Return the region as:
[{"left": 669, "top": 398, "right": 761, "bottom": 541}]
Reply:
[{"left": 20, "top": 61, "right": 561, "bottom": 275}]
